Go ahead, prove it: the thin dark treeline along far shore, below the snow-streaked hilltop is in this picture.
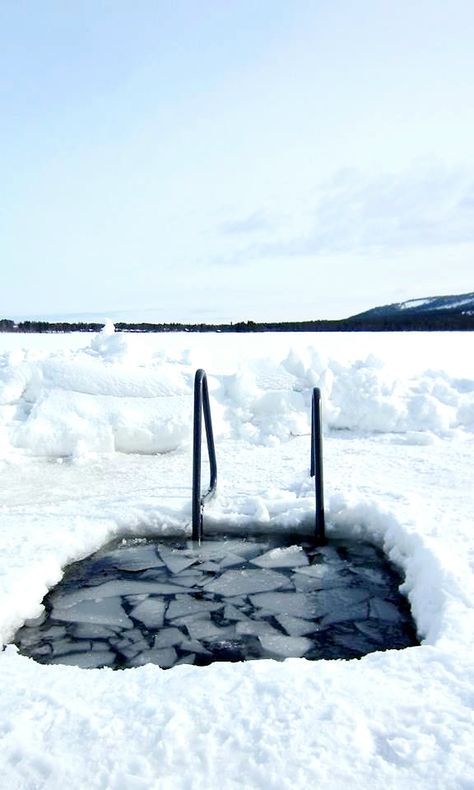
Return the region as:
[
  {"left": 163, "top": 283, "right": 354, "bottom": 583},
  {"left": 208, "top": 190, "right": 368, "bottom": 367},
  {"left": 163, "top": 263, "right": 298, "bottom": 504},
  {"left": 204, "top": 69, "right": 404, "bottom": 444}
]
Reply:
[{"left": 0, "top": 310, "right": 474, "bottom": 333}]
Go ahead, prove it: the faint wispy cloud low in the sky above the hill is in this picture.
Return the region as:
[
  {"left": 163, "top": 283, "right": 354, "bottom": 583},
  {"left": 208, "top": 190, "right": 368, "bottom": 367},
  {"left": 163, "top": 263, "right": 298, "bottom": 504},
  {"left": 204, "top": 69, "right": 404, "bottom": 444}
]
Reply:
[{"left": 260, "top": 163, "right": 474, "bottom": 256}]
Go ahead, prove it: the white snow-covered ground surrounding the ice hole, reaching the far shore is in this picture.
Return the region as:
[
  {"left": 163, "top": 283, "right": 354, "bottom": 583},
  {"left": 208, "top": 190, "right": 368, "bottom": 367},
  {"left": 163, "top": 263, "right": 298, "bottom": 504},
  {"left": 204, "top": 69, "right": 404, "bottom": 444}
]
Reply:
[{"left": 0, "top": 327, "right": 474, "bottom": 790}]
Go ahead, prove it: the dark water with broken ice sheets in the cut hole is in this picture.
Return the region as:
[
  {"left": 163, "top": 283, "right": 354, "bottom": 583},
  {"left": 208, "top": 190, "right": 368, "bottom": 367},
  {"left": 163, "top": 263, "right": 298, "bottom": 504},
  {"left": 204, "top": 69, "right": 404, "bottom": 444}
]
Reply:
[{"left": 15, "top": 536, "right": 418, "bottom": 669}]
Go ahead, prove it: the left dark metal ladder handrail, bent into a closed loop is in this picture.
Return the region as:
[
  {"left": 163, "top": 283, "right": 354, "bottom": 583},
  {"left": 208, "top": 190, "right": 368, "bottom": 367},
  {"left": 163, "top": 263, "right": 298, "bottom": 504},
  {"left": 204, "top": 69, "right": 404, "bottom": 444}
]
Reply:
[{"left": 192, "top": 368, "right": 217, "bottom": 542}]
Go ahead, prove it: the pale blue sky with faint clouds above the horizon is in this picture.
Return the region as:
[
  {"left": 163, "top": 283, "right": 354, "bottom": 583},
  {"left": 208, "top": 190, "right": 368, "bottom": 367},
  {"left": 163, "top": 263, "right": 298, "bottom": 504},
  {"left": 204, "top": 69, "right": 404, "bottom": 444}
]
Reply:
[{"left": 0, "top": 0, "right": 474, "bottom": 322}]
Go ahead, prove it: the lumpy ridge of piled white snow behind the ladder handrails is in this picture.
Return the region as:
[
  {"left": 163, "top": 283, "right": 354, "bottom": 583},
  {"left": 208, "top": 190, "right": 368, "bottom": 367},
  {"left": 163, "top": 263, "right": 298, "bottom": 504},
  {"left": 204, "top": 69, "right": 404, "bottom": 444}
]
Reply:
[{"left": 0, "top": 324, "right": 474, "bottom": 457}]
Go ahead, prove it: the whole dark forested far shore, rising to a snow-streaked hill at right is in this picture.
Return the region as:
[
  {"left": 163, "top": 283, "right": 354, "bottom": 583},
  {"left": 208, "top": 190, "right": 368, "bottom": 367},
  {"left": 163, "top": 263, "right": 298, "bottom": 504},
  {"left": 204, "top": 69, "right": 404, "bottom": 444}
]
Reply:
[{"left": 0, "top": 293, "right": 474, "bottom": 332}]
